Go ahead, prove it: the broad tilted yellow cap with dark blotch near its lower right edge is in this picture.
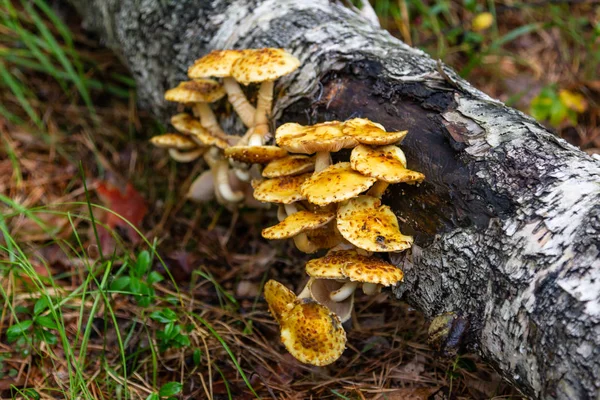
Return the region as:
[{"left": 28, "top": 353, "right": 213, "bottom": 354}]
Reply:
[{"left": 337, "top": 196, "right": 413, "bottom": 251}]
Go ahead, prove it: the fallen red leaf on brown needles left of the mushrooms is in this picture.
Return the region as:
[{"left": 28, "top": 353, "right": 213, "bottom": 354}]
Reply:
[{"left": 96, "top": 182, "right": 148, "bottom": 243}]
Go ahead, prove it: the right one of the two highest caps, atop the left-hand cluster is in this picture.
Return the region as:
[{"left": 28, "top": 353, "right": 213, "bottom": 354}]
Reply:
[{"left": 231, "top": 48, "right": 300, "bottom": 85}]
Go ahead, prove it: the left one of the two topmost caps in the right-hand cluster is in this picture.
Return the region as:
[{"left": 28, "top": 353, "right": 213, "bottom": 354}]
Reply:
[{"left": 275, "top": 121, "right": 358, "bottom": 154}]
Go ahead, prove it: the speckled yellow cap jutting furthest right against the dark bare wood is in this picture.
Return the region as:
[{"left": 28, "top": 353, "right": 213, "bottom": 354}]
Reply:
[{"left": 350, "top": 145, "right": 425, "bottom": 183}]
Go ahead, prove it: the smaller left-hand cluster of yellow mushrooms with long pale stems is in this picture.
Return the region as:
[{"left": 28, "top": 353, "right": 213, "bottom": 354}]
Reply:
[{"left": 151, "top": 48, "right": 300, "bottom": 207}]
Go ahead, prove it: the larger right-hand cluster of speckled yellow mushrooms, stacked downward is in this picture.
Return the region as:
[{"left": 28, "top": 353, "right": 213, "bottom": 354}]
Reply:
[{"left": 252, "top": 118, "right": 425, "bottom": 365}]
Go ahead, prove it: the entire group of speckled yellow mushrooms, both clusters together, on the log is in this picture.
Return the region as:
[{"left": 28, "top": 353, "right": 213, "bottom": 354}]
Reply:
[{"left": 151, "top": 49, "right": 425, "bottom": 366}]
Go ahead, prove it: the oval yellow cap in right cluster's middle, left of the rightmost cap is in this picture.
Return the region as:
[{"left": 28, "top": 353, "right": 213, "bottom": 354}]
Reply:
[{"left": 300, "top": 162, "right": 377, "bottom": 206}]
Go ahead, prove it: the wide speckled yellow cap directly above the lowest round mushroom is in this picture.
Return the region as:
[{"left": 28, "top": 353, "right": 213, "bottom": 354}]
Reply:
[{"left": 306, "top": 250, "right": 404, "bottom": 286}]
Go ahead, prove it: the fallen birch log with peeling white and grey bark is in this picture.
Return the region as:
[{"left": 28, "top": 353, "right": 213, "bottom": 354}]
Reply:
[{"left": 73, "top": 0, "right": 600, "bottom": 399}]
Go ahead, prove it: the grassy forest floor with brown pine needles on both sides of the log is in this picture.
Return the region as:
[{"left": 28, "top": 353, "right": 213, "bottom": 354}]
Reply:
[{"left": 0, "top": 0, "right": 600, "bottom": 399}]
